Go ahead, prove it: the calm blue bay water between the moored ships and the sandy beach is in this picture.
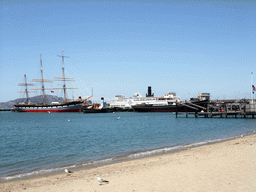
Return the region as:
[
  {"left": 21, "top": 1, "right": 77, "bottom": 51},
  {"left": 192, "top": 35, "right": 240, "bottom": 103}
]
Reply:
[{"left": 0, "top": 112, "right": 256, "bottom": 181}]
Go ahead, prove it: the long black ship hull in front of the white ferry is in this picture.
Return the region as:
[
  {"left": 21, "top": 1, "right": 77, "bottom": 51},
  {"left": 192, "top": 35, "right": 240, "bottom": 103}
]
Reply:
[{"left": 132, "top": 100, "right": 209, "bottom": 112}]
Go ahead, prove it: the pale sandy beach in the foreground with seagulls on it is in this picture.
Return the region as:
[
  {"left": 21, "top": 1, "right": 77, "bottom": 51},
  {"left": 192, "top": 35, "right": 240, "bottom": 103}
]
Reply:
[{"left": 0, "top": 135, "right": 256, "bottom": 192}]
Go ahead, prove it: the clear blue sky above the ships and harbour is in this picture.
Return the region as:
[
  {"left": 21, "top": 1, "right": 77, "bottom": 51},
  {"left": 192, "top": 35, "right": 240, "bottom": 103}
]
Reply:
[{"left": 0, "top": 0, "right": 256, "bottom": 102}]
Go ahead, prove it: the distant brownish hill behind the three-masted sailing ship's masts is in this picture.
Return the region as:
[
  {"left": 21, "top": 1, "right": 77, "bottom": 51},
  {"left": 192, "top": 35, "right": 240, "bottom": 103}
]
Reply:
[{"left": 0, "top": 95, "right": 63, "bottom": 109}]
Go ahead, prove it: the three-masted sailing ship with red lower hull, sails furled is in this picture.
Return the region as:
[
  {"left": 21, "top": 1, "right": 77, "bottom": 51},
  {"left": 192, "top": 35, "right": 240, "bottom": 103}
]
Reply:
[{"left": 14, "top": 51, "right": 83, "bottom": 113}]
